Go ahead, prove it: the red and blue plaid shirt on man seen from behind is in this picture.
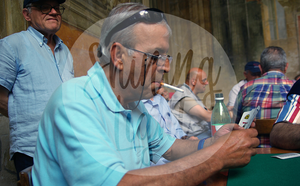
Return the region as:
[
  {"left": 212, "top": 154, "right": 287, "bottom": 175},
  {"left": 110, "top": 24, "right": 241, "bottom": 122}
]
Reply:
[{"left": 235, "top": 71, "right": 295, "bottom": 147}]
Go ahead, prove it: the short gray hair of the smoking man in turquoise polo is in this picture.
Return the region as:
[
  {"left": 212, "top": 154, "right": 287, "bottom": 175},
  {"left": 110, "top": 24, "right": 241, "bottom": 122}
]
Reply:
[{"left": 97, "top": 3, "right": 171, "bottom": 63}]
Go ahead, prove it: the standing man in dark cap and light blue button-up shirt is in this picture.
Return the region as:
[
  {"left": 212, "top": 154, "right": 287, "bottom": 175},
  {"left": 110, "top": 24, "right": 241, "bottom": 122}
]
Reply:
[{"left": 0, "top": 0, "right": 74, "bottom": 179}]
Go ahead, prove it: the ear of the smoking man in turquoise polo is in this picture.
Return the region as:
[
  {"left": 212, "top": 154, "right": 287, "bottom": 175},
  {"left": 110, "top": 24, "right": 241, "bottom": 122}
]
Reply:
[{"left": 110, "top": 42, "right": 124, "bottom": 70}]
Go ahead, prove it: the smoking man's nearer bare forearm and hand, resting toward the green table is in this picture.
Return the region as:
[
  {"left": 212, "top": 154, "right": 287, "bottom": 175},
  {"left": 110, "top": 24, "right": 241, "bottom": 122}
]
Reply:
[{"left": 119, "top": 129, "right": 259, "bottom": 185}]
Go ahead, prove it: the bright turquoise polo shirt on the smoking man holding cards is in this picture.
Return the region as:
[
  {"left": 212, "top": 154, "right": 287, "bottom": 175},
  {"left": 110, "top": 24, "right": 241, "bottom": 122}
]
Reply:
[{"left": 32, "top": 63, "right": 175, "bottom": 186}]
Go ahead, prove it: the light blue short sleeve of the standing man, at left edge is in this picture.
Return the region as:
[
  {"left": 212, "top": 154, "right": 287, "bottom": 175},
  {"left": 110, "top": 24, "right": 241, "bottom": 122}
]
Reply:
[{"left": 0, "top": 39, "right": 17, "bottom": 91}]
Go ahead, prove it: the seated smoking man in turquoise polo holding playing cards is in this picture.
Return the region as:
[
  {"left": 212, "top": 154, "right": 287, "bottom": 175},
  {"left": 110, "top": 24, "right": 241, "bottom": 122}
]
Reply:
[{"left": 32, "top": 3, "right": 258, "bottom": 186}]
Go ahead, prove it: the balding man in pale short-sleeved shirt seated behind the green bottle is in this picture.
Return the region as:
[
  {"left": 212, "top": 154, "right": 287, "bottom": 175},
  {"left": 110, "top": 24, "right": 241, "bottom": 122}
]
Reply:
[{"left": 169, "top": 68, "right": 212, "bottom": 139}]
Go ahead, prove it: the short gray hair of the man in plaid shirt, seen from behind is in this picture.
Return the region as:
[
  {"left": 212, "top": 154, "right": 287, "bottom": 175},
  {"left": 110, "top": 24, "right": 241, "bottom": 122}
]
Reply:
[{"left": 260, "top": 46, "right": 287, "bottom": 72}]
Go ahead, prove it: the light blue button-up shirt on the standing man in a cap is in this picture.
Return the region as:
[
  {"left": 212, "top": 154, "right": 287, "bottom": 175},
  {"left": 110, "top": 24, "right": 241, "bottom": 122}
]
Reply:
[{"left": 0, "top": 27, "right": 74, "bottom": 157}]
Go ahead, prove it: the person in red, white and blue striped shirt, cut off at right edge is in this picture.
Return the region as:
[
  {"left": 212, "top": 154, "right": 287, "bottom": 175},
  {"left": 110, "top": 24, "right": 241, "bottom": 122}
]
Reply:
[{"left": 270, "top": 80, "right": 300, "bottom": 149}]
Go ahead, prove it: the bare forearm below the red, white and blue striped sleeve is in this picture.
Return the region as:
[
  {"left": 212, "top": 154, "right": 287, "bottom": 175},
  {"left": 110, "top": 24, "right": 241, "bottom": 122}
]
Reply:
[{"left": 270, "top": 122, "right": 300, "bottom": 149}]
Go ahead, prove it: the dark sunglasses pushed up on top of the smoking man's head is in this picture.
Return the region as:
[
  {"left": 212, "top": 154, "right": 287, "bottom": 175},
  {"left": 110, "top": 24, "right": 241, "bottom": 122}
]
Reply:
[{"left": 105, "top": 8, "right": 167, "bottom": 46}]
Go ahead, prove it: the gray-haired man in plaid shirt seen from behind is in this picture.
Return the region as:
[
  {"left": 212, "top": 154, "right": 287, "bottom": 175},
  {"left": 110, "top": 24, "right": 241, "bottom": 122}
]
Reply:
[{"left": 235, "top": 46, "right": 295, "bottom": 147}]
